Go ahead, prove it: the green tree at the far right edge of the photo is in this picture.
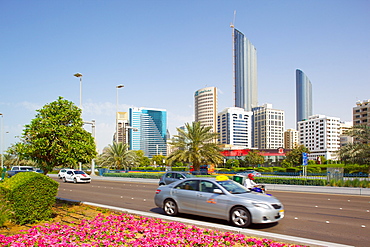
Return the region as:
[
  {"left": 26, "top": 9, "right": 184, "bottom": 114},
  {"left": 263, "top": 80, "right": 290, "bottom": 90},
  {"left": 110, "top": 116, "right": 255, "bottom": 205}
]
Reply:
[{"left": 339, "top": 125, "right": 370, "bottom": 170}]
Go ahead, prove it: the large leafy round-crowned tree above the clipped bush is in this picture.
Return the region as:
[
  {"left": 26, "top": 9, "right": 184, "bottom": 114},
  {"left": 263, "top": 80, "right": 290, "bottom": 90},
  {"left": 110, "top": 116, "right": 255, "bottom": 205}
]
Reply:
[{"left": 15, "top": 97, "right": 97, "bottom": 174}]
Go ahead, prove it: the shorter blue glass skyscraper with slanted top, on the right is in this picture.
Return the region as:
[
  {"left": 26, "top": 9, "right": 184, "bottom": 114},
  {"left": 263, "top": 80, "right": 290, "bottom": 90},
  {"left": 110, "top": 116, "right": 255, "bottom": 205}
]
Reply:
[{"left": 296, "top": 69, "right": 312, "bottom": 124}]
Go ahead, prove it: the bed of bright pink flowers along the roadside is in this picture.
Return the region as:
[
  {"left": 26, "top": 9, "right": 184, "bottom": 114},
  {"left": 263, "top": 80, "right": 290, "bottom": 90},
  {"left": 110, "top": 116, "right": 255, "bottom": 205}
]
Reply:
[{"left": 0, "top": 214, "right": 304, "bottom": 247}]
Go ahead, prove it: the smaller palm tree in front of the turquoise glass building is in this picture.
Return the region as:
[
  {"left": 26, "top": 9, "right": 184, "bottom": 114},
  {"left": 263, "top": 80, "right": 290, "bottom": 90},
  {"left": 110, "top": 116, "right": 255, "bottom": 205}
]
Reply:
[{"left": 101, "top": 142, "right": 137, "bottom": 170}]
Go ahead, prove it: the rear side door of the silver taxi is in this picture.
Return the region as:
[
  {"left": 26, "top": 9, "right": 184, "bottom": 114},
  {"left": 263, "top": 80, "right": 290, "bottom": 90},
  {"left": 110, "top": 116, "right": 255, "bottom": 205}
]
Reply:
[{"left": 172, "top": 180, "right": 199, "bottom": 214}]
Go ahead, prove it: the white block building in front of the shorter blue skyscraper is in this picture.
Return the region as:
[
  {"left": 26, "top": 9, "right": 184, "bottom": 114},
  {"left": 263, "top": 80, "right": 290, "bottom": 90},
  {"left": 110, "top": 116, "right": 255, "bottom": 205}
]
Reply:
[{"left": 298, "top": 115, "right": 340, "bottom": 160}]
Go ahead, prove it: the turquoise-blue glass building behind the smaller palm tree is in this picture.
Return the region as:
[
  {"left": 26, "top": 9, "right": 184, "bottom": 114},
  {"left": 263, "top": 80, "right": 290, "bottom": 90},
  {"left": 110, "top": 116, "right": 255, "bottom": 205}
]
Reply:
[{"left": 129, "top": 108, "right": 167, "bottom": 158}]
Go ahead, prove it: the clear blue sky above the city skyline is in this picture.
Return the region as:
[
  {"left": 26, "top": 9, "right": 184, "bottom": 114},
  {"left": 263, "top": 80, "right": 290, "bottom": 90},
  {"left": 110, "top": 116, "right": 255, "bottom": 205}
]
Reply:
[{"left": 0, "top": 0, "right": 370, "bottom": 152}]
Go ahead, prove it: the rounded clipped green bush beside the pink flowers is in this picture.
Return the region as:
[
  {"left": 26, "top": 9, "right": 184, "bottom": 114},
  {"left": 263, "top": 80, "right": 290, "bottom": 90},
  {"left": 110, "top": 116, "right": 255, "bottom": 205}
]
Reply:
[{"left": 0, "top": 172, "right": 59, "bottom": 225}]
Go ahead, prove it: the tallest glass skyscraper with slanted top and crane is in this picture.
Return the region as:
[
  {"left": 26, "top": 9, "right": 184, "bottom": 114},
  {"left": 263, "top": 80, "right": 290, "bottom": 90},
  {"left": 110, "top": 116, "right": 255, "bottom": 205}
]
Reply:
[{"left": 231, "top": 24, "right": 258, "bottom": 111}]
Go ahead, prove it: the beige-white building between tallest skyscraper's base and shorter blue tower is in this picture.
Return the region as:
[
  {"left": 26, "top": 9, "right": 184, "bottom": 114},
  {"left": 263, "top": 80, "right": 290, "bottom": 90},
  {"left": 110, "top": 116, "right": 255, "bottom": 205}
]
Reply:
[{"left": 253, "top": 104, "right": 285, "bottom": 149}]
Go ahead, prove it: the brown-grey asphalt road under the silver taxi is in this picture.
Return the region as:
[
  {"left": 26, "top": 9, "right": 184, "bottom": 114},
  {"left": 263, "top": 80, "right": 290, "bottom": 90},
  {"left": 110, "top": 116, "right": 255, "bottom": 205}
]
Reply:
[{"left": 54, "top": 178, "right": 370, "bottom": 247}]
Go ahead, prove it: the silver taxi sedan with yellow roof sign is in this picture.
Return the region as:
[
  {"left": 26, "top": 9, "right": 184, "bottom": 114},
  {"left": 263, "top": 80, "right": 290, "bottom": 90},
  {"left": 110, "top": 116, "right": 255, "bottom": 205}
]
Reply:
[{"left": 154, "top": 176, "right": 284, "bottom": 227}]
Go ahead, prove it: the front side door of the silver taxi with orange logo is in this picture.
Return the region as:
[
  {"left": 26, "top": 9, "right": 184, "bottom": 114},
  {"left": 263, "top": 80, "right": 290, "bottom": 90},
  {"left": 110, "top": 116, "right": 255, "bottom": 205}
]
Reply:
[{"left": 197, "top": 180, "right": 230, "bottom": 219}]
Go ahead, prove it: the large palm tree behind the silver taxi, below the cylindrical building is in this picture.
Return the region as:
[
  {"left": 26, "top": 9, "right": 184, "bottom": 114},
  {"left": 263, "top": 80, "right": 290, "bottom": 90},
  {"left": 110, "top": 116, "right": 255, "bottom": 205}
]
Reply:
[{"left": 167, "top": 122, "right": 223, "bottom": 171}]
